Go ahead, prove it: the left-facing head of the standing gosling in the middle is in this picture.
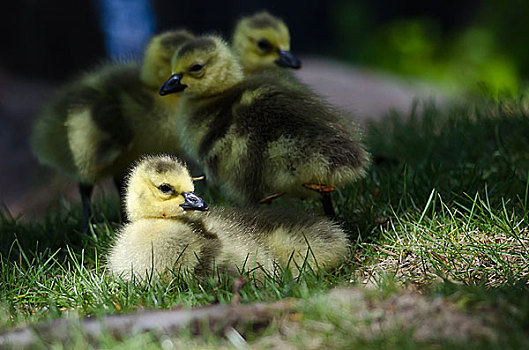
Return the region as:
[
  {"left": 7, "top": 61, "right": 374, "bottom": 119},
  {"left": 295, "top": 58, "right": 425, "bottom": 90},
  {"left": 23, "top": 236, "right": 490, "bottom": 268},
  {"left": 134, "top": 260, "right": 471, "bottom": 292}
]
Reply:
[{"left": 159, "top": 35, "right": 243, "bottom": 97}]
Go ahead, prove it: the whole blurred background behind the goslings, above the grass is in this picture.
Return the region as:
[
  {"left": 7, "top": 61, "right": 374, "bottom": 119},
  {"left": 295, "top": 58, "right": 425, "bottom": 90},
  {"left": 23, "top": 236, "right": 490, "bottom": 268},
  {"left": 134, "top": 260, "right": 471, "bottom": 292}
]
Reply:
[{"left": 0, "top": 0, "right": 529, "bottom": 219}]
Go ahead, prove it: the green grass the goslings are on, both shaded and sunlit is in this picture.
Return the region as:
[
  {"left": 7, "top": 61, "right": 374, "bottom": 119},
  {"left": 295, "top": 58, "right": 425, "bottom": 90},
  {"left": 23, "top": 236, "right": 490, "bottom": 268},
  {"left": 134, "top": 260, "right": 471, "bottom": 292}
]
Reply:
[{"left": 0, "top": 95, "right": 529, "bottom": 348}]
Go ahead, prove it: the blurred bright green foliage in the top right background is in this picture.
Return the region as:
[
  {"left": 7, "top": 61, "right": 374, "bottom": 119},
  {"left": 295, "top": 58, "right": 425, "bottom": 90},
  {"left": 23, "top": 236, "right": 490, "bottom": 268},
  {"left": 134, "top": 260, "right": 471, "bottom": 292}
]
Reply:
[{"left": 331, "top": 0, "right": 529, "bottom": 92}]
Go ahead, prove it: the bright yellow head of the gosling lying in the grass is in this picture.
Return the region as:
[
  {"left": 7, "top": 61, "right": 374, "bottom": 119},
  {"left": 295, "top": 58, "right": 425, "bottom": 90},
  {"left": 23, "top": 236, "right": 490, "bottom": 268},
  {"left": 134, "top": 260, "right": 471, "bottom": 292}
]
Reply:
[{"left": 125, "top": 155, "right": 208, "bottom": 221}]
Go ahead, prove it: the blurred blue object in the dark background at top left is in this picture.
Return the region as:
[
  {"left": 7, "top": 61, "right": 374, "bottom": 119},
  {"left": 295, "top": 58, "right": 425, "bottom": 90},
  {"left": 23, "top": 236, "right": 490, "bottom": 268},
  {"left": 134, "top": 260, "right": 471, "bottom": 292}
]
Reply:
[{"left": 99, "top": 0, "right": 155, "bottom": 60}]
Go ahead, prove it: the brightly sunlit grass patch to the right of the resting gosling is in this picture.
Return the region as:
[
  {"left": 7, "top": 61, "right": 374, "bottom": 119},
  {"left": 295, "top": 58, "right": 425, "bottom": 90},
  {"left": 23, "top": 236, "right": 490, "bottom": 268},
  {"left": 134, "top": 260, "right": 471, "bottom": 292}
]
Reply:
[{"left": 357, "top": 191, "right": 529, "bottom": 286}]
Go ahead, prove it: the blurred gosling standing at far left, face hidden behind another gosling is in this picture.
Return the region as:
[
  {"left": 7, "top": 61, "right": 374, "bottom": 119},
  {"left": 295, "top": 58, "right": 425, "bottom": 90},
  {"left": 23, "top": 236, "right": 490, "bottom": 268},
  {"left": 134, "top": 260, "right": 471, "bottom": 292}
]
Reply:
[{"left": 31, "top": 31, "right": 192, "bottom": 231}]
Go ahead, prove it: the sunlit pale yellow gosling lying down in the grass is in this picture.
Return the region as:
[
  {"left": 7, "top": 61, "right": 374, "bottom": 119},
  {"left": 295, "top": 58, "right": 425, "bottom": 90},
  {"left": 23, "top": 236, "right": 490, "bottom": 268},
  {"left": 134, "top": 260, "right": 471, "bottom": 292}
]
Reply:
[{"left": 108, "top": 156, "right": 349, "bottom": 280}]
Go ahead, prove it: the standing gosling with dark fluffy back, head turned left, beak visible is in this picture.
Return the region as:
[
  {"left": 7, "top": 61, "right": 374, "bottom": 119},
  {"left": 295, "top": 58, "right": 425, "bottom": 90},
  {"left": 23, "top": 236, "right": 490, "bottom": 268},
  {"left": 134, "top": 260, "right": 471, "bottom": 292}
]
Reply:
[{"left": 160, "top": 36, "right": 370, "bottom": 216}]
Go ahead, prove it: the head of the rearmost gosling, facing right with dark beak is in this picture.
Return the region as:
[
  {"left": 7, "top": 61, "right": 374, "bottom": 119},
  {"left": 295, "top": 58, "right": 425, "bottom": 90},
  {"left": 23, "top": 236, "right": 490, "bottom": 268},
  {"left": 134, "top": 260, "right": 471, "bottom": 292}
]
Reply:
[{"left": 233, "top": 12, "right": 301, "bottom": 73}]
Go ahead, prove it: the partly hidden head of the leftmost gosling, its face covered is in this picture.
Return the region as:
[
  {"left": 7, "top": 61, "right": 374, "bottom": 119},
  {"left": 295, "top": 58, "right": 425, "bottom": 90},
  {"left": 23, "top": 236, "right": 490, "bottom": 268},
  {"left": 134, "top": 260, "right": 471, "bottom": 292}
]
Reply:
[{"left": 141, "top": 30, "right": 194, "bottom": 89}]
